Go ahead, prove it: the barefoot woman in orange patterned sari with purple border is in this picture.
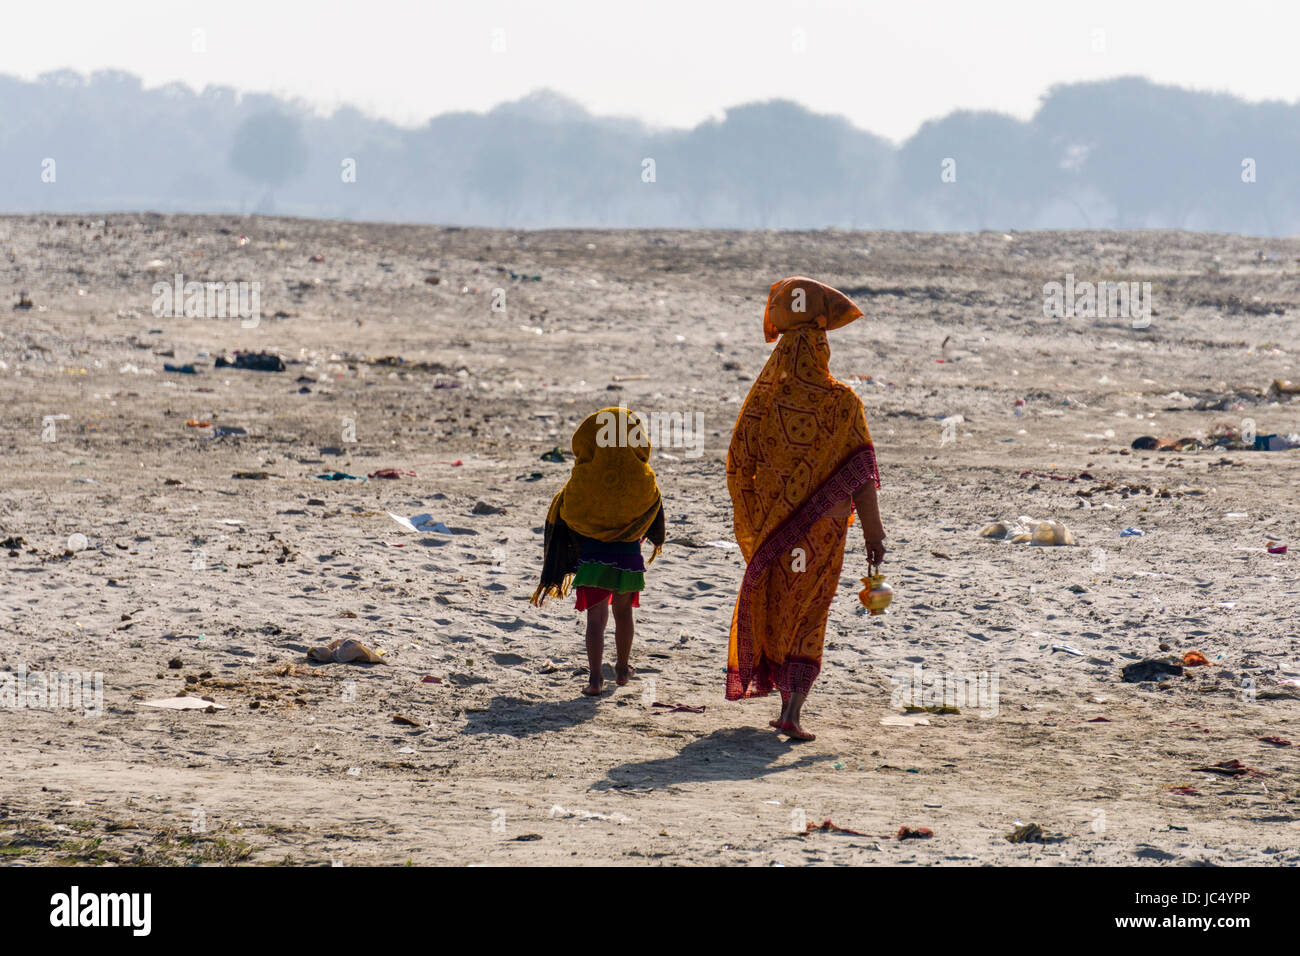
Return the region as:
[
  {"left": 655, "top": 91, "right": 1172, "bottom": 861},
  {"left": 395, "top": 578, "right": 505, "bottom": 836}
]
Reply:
[{"left": 727, "top": 276, "right": 885, "bottom": 740}]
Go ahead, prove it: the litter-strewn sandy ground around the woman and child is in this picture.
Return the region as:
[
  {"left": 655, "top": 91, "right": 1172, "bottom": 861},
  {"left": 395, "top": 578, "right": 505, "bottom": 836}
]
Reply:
[{"left": 0, "top": 216, "right": 1300, "bottom": 865}]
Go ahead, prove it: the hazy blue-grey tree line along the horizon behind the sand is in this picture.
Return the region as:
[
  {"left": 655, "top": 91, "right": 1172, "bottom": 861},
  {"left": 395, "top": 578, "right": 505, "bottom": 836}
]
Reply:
[{"left": 0, "top": 72, "right": 1300, "bottom": 235}]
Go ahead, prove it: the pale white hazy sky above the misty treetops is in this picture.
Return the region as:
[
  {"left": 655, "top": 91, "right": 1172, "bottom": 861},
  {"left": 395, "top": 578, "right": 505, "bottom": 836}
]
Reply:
[{"left": 10, "top": 0, "right": 1300, "bottom": 140}]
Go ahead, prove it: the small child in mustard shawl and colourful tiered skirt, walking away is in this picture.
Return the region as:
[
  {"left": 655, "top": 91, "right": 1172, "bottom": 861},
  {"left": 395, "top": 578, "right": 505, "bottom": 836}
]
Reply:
[{"left": 532, "top": 406, "right": 664, "bottom": 697}]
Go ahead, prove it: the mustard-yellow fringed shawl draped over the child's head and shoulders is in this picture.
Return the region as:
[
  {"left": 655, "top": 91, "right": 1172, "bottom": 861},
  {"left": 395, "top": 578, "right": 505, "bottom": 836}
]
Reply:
[{"left": 533, "top": 406, "right": 664, "bottom": 605}]
